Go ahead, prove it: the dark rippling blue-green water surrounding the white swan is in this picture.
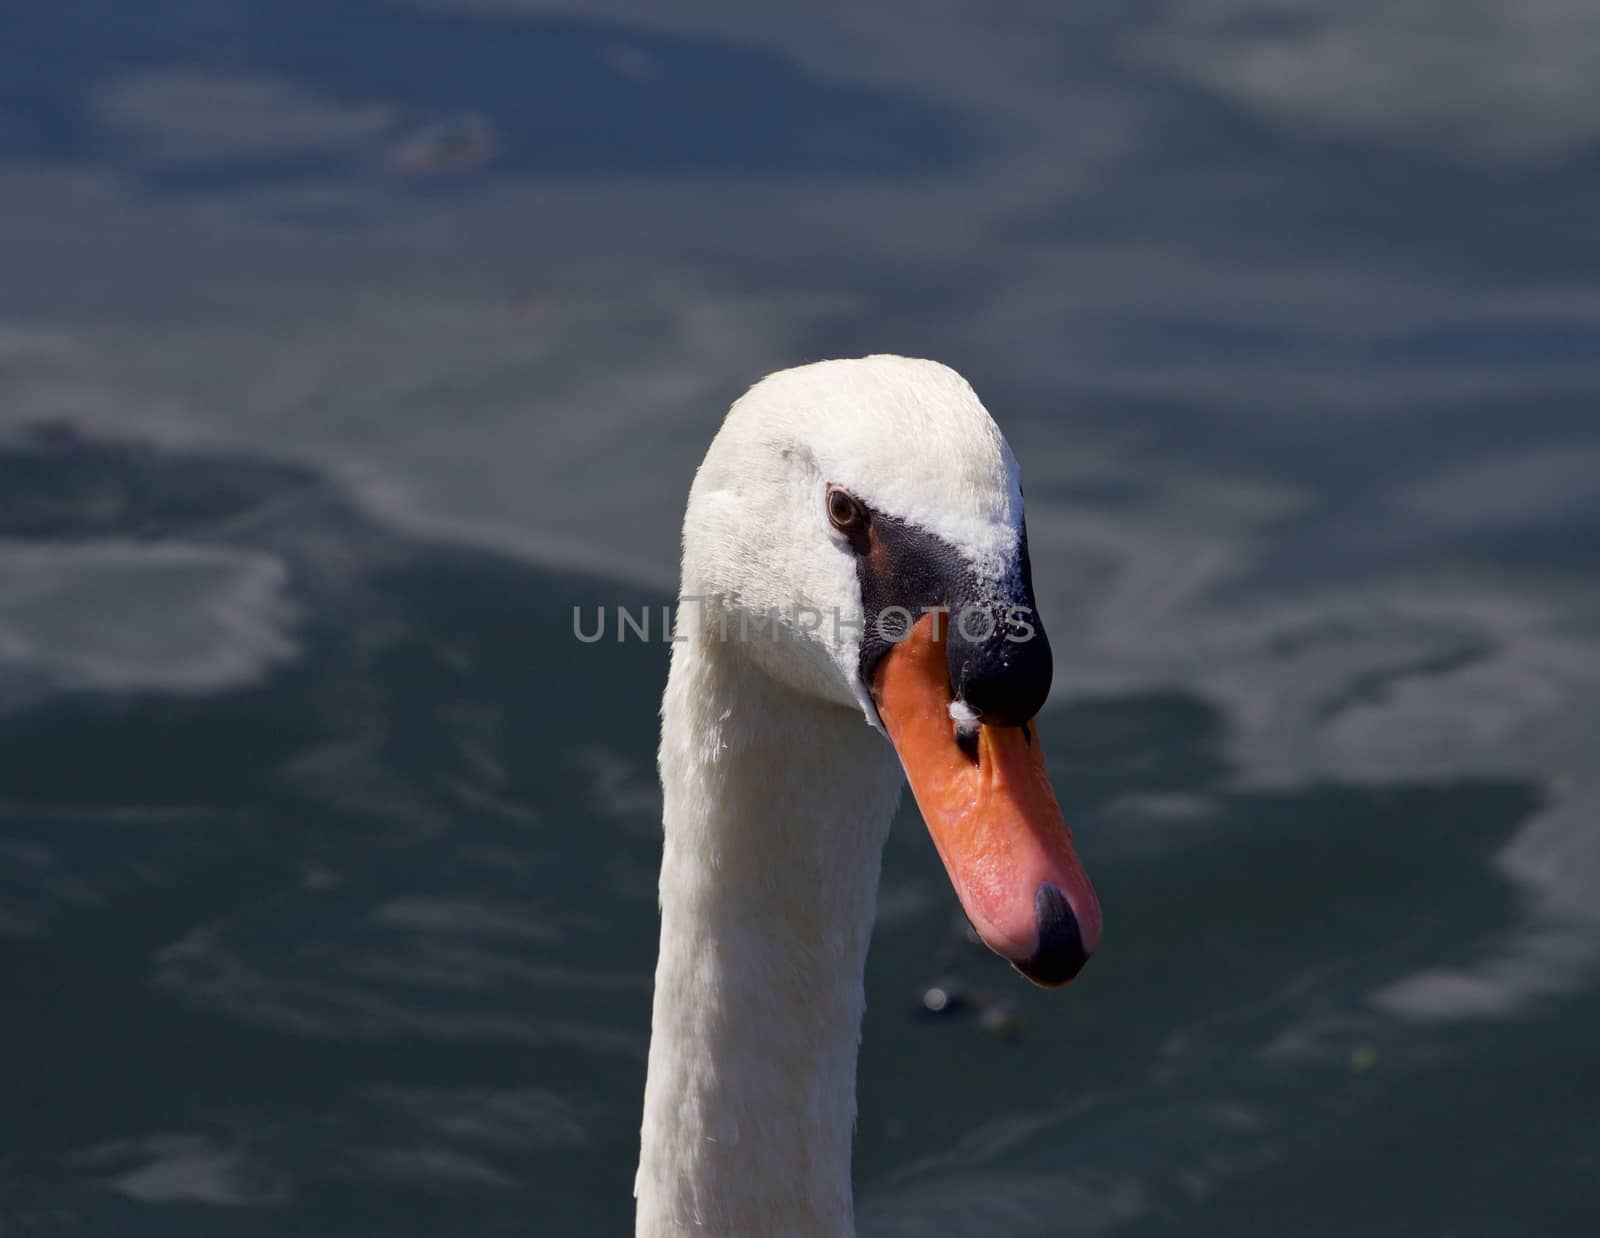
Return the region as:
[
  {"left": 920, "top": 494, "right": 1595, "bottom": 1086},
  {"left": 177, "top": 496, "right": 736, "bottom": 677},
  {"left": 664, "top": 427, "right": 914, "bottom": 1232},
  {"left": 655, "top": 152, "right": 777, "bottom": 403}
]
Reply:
[{"left": 0, "top": 0, "right": 1600, "bottom": 1238}]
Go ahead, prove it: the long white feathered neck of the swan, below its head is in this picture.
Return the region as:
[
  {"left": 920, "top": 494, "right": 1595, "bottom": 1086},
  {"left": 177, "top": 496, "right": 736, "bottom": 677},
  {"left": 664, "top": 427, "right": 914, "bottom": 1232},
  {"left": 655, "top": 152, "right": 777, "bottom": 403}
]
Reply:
[{"left": 635, "top": 633, "right": 901, "bottom": 1238}]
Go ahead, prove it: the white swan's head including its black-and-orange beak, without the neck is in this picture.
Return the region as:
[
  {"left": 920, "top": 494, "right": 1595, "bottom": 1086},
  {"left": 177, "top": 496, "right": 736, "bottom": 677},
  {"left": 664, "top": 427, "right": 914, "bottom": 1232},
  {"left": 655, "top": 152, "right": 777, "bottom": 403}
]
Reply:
[{"left": 680, "top": 357, "right": 1101, "bottom": 984}]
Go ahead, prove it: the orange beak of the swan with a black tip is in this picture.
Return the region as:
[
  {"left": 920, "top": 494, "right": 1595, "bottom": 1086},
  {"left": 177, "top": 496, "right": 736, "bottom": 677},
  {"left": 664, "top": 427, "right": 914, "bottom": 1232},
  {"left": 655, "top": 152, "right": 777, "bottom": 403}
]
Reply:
[{"left": 872, "top": 614, "right": 1101, "bottom": 985}]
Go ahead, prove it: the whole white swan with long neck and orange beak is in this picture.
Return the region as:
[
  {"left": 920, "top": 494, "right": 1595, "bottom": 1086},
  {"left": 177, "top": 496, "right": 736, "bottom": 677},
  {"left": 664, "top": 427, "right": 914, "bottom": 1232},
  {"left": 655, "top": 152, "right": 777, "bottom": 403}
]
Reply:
[{"left": 634, "top": 355, "right": 1101, "bottom": 1238}]
